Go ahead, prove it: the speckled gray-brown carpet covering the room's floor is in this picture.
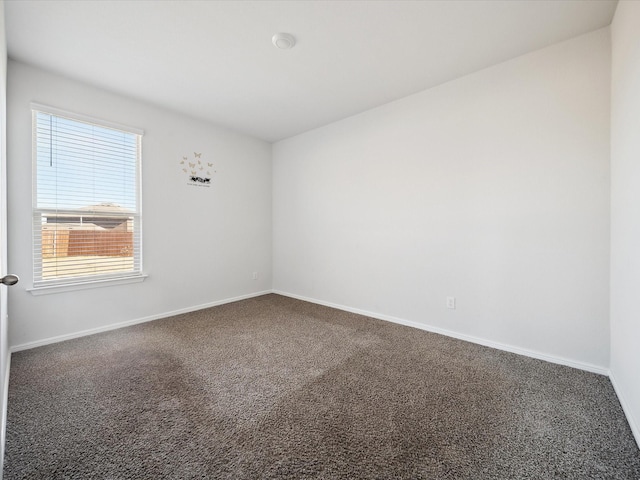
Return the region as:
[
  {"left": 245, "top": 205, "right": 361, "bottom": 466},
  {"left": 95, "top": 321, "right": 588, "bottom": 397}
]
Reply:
[{"left": 4, "top": 295, "right": 640, "bottom": 480}]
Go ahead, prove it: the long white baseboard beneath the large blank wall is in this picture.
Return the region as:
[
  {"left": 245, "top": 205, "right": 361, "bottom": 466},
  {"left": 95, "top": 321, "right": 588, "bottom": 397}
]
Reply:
[{"left": 273, "top": 290, "right": 609, "bottom": 376}]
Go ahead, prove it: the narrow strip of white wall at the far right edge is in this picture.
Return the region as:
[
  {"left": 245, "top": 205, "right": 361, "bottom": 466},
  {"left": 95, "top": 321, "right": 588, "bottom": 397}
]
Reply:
[{"left": 611, "top": 1, "right": 640, "bottom": 445}]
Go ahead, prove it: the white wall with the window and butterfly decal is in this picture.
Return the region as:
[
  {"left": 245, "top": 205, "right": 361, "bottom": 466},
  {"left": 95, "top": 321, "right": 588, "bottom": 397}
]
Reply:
[{"left": 7, "top": 60, "right": 271, "bottom": 346}]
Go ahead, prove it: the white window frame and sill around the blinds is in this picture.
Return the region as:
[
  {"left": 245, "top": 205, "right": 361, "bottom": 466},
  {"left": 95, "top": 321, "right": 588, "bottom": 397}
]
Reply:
[{"left": 27, "top": 103, "right": 147, "bottom": 295}]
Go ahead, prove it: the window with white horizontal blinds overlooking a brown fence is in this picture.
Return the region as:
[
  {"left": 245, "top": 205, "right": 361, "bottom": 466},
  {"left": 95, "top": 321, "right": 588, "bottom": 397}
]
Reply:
[{"left": 32, "top": 105, "right": 142, "bottom": 292}]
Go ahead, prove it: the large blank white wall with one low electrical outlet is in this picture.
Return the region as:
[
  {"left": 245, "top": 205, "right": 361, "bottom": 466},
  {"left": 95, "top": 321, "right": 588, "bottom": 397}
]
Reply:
[{"left": 273, "top": 28, "right": 610, "bottom": 370}]
